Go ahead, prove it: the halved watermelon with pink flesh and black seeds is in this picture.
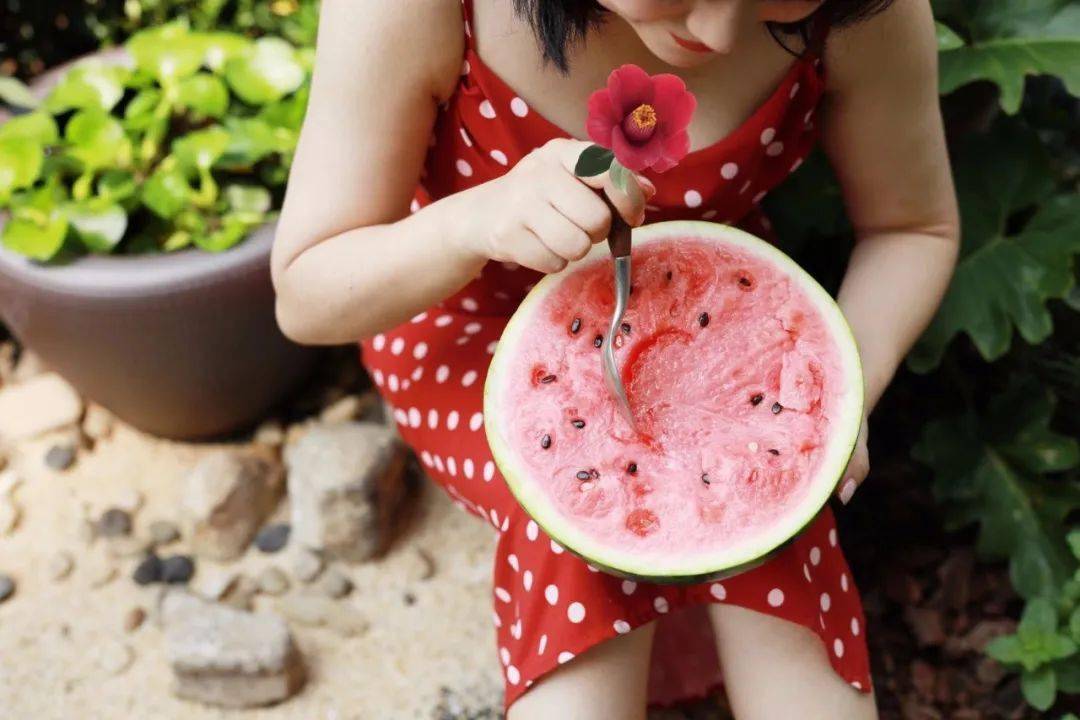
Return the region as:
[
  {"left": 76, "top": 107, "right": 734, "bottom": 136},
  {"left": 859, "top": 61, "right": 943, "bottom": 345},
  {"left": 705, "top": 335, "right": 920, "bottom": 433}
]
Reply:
[{"left": 484, "top": 221, "right": 863, "bottom": 582}]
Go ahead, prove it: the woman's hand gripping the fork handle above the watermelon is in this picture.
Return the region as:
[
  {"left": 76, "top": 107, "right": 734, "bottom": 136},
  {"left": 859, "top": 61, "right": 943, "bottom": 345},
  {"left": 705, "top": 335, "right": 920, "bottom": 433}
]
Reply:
[{"left": 448, "top": 139, "right": 656, "bottom": 273}]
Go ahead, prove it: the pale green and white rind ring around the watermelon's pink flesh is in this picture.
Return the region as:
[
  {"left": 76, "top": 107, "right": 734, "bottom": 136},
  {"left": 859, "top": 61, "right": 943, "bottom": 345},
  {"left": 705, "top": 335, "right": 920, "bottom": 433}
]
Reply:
[{"left": 484, "top": 220, "right": 864, "bottom": 583}]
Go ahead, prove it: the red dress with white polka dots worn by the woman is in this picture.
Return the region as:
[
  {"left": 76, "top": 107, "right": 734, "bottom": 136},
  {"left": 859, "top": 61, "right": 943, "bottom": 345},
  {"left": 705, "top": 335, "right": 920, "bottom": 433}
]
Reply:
[{"left": 363, "top": 0, "right": 870, "bottom": 707}]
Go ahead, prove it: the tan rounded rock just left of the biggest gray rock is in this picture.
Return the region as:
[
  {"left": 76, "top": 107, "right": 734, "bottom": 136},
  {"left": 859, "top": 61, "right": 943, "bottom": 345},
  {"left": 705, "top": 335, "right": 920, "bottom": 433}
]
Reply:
[{"left": 183, "top": 450, "right": 283, "bottom": 560}]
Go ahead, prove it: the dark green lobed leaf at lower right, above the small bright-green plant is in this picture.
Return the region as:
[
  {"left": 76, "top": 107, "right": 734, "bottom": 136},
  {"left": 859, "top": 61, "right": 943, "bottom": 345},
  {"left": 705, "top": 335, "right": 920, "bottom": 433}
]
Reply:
[{"left": 912, "top": 382, "right": 1080, "bottom": 598}]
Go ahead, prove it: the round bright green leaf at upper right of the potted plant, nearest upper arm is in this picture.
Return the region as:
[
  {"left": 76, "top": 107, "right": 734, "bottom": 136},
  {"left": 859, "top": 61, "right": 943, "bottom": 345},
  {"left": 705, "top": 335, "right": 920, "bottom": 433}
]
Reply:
[{"left": 225, "top": 38, "right": 306, "bottom": 105}]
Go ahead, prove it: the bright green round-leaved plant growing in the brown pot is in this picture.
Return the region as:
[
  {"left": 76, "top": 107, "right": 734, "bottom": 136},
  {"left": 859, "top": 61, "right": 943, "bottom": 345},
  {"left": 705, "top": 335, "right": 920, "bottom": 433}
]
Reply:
[{"left": 0, "top": 23, "right": 311, "bottom": 261}]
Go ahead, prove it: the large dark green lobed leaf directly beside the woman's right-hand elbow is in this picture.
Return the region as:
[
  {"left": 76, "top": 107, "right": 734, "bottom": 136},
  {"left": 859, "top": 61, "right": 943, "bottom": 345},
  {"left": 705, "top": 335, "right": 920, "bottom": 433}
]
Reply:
[{"left": 908, "top": 124, "right": 1080, "bottom": 372}]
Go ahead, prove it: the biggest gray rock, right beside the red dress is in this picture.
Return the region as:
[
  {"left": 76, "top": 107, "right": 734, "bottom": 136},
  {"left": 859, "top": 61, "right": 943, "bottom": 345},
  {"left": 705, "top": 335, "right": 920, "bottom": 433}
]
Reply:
[{"left": 285, "top": 422, "right": 405, "bottom": 562}]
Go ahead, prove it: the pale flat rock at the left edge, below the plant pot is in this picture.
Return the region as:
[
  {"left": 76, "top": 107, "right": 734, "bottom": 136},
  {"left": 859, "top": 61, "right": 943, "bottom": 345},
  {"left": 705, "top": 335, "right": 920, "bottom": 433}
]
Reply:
[{"left": 0, "top": 372, "right": 82, "bottom": 443}]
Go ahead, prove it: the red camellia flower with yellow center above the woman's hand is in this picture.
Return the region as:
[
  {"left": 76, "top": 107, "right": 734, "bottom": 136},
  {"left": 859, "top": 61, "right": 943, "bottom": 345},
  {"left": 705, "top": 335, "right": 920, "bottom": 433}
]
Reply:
[{"left": 585, "top": 65, "right": 698, "bottom": 173}]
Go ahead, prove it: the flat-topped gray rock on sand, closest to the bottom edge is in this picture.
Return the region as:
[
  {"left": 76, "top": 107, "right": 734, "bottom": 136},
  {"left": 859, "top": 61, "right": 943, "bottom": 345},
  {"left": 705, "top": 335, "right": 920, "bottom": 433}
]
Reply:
[{"left": 162, "top": 593, "right": 306, "bottom": 707}]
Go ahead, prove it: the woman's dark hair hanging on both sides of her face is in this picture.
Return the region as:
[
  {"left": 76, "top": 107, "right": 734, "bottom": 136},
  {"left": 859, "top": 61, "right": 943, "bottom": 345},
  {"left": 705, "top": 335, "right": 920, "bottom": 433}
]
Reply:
[{"left": 514, "top": 0, "right": 892, "bottom": 72}]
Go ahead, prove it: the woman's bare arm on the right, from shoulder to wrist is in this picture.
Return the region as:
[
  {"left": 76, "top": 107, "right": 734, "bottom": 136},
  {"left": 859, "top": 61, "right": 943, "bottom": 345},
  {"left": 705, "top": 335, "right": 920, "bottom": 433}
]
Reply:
[{"left": 823, "top": 0, "right": 959, "bottom": 414}]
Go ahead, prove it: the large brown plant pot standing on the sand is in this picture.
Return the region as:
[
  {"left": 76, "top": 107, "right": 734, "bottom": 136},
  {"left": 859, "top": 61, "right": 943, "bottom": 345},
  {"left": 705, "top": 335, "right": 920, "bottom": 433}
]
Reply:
[{"left": 0, "top": 51, "right": 318, "bottom": 438}]
